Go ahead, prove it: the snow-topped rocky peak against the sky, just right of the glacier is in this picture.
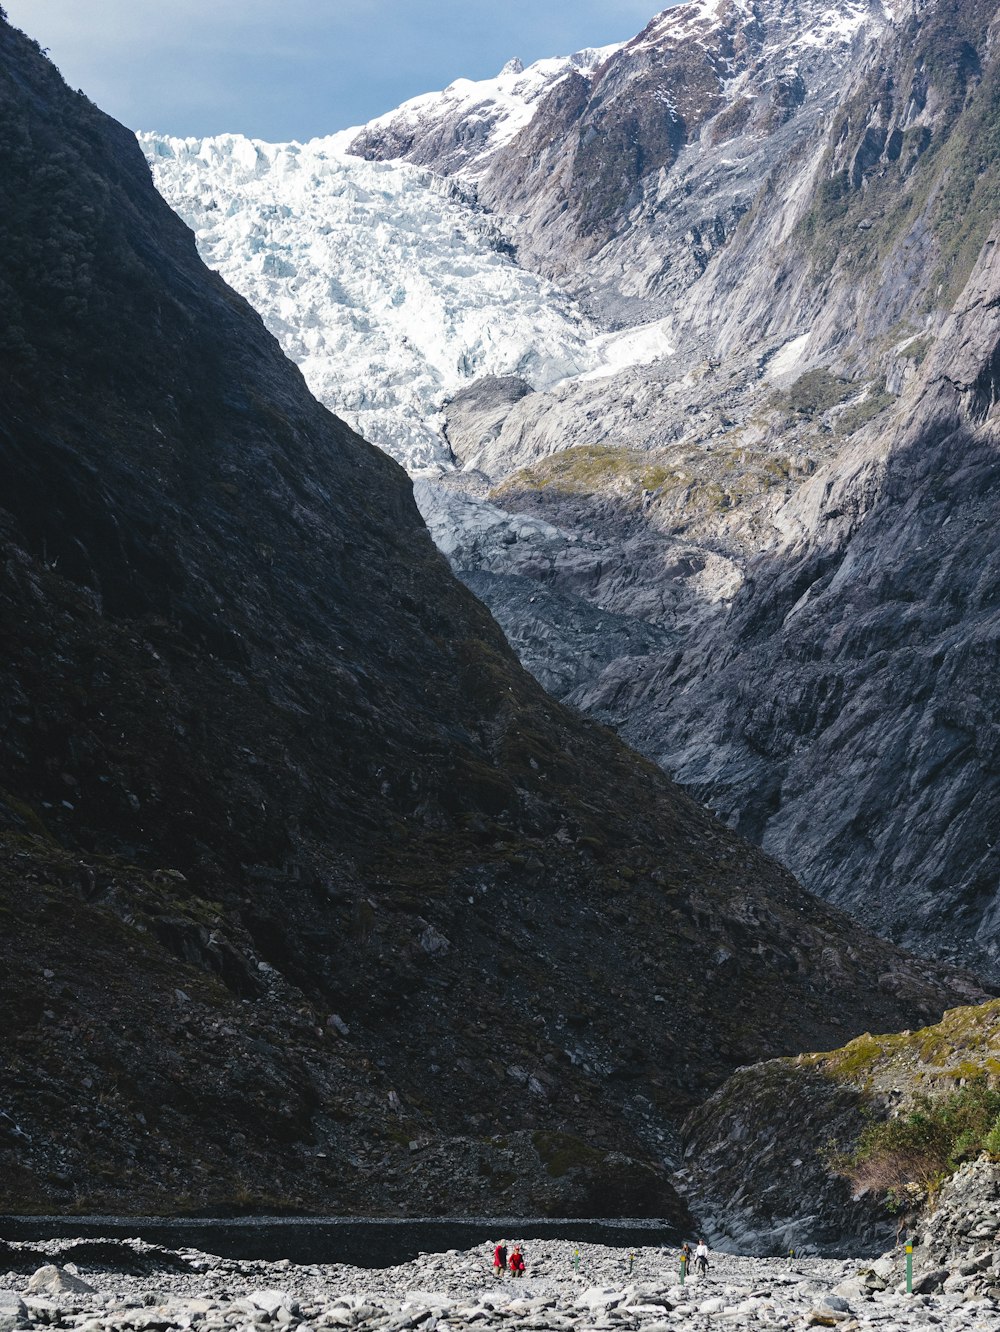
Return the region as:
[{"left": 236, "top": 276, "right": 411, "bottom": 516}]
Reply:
[{"left": 352, "top": 0, "right": 891, "bottom": 314}]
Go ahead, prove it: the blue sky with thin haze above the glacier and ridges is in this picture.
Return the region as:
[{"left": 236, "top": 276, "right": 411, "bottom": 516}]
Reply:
[{"left": 7, "top": 0, "right": 664, "bottom": 140}]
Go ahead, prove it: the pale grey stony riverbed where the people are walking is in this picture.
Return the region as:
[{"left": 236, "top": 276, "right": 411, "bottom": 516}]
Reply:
[{"left": 0, "top": 1233, "right": 1000, "bottom": 1332}]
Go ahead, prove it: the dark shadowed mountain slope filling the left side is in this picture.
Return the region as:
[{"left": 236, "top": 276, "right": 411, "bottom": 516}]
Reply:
[{"left": 0, "top": 10, "right": 981, "bottom": 1220}]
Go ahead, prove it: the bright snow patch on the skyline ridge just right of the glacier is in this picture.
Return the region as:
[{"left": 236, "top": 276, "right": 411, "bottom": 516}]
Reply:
[{"left": 354, "top": 43, "right": 622, "bottom": 176}]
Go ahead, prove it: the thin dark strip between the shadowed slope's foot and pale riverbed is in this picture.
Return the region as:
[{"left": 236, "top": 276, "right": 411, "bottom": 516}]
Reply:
[{"left": 0, "top": 1216, "right": 679, "bottom": 1267}]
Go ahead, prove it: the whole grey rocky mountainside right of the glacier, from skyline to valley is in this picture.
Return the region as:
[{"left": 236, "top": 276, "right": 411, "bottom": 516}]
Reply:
[{"left": 340, "top": 0, "right": 1000, "bottom": 974}]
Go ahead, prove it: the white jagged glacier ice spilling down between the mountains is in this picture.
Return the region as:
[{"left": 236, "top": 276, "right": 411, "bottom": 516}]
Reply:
[{"left": 138, "top": 131, "right": 670, "bottom": 476}]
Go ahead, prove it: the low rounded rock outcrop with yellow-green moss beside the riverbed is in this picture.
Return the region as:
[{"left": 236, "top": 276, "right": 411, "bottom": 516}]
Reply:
[{"left": 676, "top": 1000, "right": 1000, "bottom": 1252}]
